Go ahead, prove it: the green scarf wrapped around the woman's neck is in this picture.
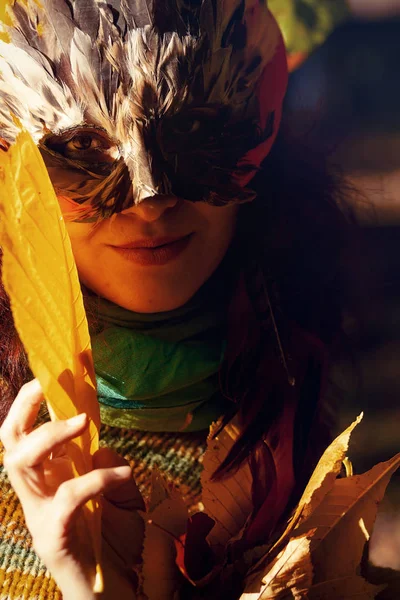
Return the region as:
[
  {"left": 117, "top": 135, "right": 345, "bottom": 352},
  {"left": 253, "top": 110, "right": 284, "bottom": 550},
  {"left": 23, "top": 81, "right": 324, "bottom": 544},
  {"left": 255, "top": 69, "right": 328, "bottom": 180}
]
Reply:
[{"left": 91, "top": 262, "right": 231, "bottom": 431}]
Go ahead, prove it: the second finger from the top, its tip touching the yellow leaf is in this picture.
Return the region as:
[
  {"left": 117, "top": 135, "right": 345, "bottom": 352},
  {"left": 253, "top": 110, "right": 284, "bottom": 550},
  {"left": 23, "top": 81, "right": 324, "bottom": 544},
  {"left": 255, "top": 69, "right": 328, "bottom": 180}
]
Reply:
[{"left": 4, "top": 413, "right": 88, "bottom": 471}]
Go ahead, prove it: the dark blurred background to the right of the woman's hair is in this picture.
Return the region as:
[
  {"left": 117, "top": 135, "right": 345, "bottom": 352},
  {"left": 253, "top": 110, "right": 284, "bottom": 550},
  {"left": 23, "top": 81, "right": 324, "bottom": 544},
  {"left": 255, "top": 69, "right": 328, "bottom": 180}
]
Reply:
[{"left": 286, "top": 7, "right": 400, "bottom": 570}]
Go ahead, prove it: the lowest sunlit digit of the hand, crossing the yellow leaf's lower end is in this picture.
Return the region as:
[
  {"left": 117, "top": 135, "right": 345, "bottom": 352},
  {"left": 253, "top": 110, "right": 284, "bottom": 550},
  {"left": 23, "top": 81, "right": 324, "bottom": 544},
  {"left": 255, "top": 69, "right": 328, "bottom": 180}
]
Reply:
[{"left": 52, "top": 465, "right": 131, "bottom": 530}]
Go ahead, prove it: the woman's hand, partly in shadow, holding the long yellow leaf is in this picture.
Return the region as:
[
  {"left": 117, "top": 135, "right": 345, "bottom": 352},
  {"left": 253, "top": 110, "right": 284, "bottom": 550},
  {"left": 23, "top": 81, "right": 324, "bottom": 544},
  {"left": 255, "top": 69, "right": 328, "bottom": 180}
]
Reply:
[{"left": 0, "top": 380, "right": 144, "bottom": 600}]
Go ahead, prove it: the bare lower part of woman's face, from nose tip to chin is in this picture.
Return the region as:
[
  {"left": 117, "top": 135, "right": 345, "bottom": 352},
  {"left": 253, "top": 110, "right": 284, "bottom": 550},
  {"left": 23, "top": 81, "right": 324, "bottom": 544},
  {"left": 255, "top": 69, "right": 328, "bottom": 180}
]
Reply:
[{"left": 67, "top": 196, "right": 238, "bottom": 313}]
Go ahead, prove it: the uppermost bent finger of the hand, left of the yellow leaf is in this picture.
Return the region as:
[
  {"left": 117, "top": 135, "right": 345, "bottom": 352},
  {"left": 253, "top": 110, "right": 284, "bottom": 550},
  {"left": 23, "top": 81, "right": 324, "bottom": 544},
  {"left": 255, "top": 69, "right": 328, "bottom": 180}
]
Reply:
[{"left": 0, "top": 379, "right": 43, "bottom": 450}]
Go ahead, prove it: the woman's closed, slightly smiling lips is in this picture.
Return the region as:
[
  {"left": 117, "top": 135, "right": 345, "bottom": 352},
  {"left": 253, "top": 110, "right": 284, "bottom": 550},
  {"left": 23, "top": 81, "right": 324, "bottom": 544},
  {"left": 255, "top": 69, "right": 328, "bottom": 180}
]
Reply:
[{"left": 111, "top": 233, "right": 193, "bottom": 266}]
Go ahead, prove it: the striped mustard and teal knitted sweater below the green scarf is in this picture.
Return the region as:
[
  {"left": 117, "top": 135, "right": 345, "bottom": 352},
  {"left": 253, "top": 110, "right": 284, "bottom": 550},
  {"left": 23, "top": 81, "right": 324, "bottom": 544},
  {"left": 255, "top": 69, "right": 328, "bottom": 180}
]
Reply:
[{"left": 0, "top": 414, "right": 206, "bottom": 600}]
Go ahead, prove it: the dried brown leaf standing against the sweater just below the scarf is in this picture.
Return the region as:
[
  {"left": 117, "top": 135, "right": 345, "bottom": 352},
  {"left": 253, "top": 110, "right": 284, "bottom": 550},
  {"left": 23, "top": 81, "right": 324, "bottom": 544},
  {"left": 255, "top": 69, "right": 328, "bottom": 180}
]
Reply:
[{"left": 201, "top": 422, "right": 253, "bottom": 547}]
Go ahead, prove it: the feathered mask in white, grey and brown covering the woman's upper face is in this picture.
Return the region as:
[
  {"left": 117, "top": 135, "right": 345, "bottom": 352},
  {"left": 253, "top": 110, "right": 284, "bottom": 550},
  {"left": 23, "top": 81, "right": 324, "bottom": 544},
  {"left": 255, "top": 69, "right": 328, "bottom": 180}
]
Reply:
[{"left": 0, "top": 0, "right": 287, "bottom": 221}]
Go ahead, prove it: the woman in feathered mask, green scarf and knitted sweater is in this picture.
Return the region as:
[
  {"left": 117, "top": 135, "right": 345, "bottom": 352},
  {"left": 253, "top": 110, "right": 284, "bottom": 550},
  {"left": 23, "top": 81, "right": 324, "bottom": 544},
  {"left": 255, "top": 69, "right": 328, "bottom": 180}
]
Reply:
[{"left": 0, "top": 0, "right": 347, "bottom": 600}]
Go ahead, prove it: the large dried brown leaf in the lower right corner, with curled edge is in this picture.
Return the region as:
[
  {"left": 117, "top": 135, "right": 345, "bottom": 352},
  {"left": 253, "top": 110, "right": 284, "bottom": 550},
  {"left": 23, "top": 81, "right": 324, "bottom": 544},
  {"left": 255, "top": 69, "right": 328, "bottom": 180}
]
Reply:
[{"left": 241, "top": 454, "right": 400, "bottom": 600}]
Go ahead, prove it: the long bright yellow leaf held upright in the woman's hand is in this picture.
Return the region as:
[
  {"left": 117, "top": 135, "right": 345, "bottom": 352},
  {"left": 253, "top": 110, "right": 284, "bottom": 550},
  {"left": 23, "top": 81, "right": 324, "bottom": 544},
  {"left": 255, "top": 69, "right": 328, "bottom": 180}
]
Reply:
[{"left": 0, "top": 132, "right": 102, "bottom": 589}]
